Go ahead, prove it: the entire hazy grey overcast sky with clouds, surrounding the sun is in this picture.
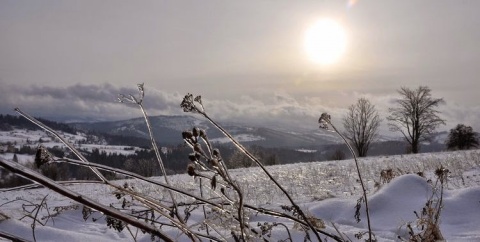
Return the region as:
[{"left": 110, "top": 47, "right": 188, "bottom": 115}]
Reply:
[{"left": 0, "top": 0, "right": 480, "bottom": 131}]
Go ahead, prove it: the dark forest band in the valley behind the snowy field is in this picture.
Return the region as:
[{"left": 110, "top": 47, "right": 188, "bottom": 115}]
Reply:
[{"left": 0, "top": 141, "right": 326, "bottom": 187}]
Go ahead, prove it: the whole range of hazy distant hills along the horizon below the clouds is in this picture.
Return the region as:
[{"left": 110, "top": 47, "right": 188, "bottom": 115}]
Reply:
[{"left": 0, "top": 112, "right": 448, "bottom": 161}]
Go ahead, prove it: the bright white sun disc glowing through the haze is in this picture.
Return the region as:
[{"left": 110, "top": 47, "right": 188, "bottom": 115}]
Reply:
[{"left": 304, "top": 19, "right": 347, "bottom": 64}]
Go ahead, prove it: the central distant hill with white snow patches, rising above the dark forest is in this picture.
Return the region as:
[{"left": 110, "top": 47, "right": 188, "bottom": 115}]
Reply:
[{"left": 72, "top": 116, "right": 340, "bottom": 148}]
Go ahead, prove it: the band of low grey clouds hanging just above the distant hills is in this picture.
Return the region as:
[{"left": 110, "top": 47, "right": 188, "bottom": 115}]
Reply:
[{"left": 0, "top": 84, "right": 480, "bottom": 135}]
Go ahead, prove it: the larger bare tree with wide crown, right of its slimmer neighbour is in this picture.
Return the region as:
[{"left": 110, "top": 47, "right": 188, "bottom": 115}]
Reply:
[{"left": 387, "top": 86, "right": 445, "bottom": 154}]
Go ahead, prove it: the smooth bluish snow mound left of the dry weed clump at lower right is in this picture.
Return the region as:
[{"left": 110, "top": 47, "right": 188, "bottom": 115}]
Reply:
[{"left": 312, "top": 174, "right": 432, "bottom": 237}]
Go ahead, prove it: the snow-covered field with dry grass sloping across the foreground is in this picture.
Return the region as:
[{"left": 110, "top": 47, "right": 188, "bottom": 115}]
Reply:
[{"left": 0, "top": 150, "right": 480, "bottom": 242}]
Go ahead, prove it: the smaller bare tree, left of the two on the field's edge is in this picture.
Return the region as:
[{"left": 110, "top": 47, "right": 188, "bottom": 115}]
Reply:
[{"left": 343, "top": 98, "right": 382, "bottom": 157}]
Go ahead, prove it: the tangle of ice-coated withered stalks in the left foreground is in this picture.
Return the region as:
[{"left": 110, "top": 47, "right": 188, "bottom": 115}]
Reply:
[{"left": 0, "top": 84, "right": 343, "bottom": 241}]
